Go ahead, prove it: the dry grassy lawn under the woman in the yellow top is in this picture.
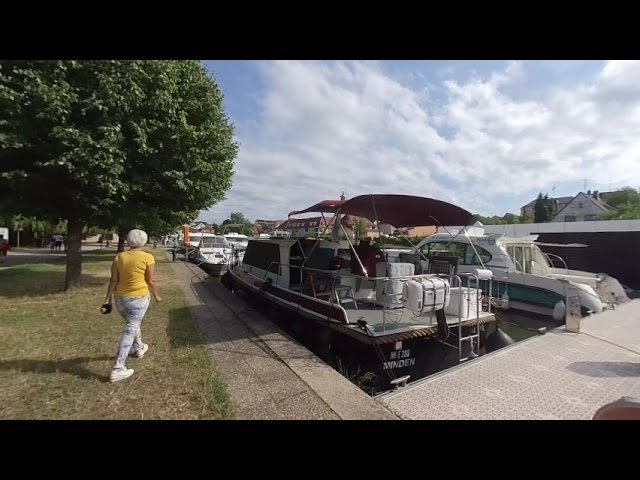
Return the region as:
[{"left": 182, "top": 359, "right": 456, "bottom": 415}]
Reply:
[{"left": 0, "top": 248, "right": 234, "bottom": 419}]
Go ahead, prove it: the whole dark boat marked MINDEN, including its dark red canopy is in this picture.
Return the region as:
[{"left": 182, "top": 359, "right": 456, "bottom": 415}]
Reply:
[{"left": 222, "top": 194, "right": 512, "bottom": 391}]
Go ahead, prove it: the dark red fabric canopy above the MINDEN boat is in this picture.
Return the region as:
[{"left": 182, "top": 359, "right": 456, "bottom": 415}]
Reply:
[{"left": 289, "top": 194, "right": 473, "bottom": 228}]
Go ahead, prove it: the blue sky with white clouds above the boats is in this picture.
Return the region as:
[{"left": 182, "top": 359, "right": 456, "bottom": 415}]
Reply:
[{"left": 200, "top": 60, "right": 640, "bottom": 222}]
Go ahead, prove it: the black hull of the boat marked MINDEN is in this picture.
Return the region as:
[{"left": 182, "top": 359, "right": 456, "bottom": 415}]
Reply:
[{"left": 224, "top": 268, "right": 487, "bottom": 394}]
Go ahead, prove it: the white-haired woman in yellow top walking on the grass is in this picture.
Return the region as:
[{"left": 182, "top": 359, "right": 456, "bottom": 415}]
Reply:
[{"left": 103, "top": 229, "right": 162, "bottom": 382}]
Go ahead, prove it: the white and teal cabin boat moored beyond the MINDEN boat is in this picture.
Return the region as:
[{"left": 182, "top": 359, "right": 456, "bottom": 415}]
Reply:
[{"left": 413, "top": 225, "right": 629, "bottom": 322}]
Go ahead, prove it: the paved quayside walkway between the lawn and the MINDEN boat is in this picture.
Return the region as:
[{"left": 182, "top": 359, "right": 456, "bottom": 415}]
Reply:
[{"left": 173, "top": 255, "right": 397, "bottom": 420}]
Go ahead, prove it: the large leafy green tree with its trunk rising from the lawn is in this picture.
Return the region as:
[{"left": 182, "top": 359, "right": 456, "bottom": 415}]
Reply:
[{"left": 0, "top": 60, "right": 238, "bottom": 289}]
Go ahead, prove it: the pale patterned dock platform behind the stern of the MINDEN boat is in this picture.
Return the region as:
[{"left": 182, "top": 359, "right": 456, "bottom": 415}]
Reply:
[{"left": 378, "top": 300, "right": 640, "bottom": 420}]
